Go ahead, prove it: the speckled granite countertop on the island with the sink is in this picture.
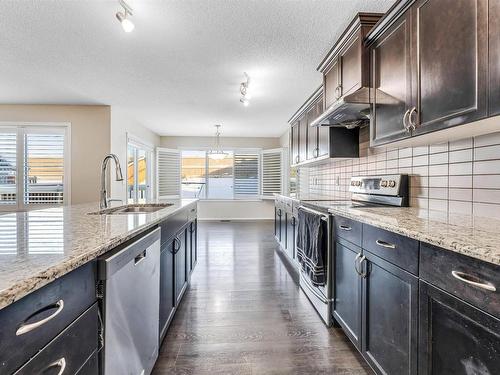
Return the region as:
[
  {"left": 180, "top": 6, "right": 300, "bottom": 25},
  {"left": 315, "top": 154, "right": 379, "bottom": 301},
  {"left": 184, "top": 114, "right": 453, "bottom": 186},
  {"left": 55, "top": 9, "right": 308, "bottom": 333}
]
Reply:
[{"left": 0, "top": 199, "right": 198, "bottom": 309}]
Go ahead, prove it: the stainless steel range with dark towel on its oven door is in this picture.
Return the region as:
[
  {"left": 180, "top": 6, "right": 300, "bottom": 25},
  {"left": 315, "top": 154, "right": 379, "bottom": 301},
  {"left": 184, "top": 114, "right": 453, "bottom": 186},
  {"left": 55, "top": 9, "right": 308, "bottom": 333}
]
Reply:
[{"left": 297, "top": 174, "right": 409, "bottom": 326}]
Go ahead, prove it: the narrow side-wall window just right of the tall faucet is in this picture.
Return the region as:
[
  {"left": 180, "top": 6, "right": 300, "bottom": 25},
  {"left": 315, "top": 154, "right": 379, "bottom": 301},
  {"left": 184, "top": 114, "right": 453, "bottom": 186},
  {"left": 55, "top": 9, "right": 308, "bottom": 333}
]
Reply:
[{"left": 127, "top": 138, "right": 152, "bottom": 203}]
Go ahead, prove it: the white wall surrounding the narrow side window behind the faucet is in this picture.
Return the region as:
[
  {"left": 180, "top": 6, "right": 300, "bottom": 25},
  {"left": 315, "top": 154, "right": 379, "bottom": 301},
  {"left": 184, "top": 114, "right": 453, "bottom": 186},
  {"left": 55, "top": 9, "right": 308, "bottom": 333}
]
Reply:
[{"left": 111, "top": 106, "right": 160, "bottom": 202}]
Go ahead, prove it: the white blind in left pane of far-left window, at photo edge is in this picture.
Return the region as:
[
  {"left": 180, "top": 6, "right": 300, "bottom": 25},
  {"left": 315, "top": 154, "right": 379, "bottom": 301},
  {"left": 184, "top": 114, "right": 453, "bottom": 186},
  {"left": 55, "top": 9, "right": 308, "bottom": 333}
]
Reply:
[{"left": 0, "top": 129, "right": 17, "bottom": 205}]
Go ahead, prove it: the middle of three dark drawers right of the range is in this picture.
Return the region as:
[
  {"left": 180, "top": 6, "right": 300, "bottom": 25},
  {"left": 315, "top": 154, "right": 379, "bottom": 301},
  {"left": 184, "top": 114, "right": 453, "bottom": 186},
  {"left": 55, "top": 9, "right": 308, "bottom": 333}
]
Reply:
[{"left": 363, "top": 224, "right": 418, "bottom": 275}]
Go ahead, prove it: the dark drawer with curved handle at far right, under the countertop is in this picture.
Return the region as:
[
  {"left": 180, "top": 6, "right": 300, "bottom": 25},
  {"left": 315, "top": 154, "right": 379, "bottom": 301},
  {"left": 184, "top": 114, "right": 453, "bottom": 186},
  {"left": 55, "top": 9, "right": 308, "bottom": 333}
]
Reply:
[{"left": 420, "top": 243, "right": 500, "bottom": 317}]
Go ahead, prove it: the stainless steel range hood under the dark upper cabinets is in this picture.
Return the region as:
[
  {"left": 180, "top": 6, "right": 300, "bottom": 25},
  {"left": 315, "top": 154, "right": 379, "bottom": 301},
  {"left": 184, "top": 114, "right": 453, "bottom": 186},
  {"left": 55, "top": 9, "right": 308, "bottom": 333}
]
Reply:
[{"left": 311, "top": 87, "right": 370, "bottom": 128}]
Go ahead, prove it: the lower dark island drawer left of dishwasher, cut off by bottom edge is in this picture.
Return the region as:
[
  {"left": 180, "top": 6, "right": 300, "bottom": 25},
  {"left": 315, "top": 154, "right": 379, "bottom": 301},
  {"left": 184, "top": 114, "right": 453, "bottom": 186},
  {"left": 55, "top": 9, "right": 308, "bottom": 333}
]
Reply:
[{"left": 15, "top": 303, "right": 99, "bottom": 375}]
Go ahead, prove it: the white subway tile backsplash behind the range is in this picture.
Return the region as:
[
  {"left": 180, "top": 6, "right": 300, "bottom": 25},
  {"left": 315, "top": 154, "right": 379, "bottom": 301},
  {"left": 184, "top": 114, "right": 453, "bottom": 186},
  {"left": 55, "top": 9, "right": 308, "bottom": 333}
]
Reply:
[{"left": 299, "top": 129, "right": 500, "bottom": 220}]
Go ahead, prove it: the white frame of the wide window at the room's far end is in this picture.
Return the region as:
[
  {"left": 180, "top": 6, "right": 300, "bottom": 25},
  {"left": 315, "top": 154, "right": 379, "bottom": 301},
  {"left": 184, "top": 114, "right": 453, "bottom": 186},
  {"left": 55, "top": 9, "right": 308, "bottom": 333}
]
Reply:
[{"left": 178, "top": 147, "right": 262, "bottom": 202}]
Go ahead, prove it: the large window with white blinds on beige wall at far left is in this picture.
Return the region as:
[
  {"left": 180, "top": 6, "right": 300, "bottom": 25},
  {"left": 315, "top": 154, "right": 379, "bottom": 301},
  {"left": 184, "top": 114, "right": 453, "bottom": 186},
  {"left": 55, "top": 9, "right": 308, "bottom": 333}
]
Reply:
[{"left": 0, "top": 125, "right": 70, "bottom": 210}]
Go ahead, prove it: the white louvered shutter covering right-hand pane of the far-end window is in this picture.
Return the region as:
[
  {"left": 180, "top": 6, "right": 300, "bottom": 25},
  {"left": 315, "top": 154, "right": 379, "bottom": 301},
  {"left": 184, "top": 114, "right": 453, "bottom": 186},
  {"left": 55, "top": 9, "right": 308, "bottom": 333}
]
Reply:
[{"left": 233, "top": 151, "right": 260, "bottom": 198}]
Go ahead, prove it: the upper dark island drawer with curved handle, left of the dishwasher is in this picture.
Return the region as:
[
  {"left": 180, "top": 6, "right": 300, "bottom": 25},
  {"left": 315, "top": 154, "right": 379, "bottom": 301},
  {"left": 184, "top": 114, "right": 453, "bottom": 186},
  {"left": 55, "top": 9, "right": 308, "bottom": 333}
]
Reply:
[{"left": 0, "top": 262, "right": 96, "bottom": 374}]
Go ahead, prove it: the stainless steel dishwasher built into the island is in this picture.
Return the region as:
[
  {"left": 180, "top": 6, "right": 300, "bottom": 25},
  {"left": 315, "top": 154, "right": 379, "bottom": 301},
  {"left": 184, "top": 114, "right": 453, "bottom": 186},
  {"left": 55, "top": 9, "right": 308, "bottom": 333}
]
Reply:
[{"left": 98, "top": 228, "right": 160, "bottom": 375}]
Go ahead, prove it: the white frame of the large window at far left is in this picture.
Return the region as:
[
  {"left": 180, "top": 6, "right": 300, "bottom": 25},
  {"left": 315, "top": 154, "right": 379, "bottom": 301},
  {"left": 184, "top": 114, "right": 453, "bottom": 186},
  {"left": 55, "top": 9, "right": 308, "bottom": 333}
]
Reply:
[{"left": 0, "top": 121, "right": 71, "bottom": 211}]
